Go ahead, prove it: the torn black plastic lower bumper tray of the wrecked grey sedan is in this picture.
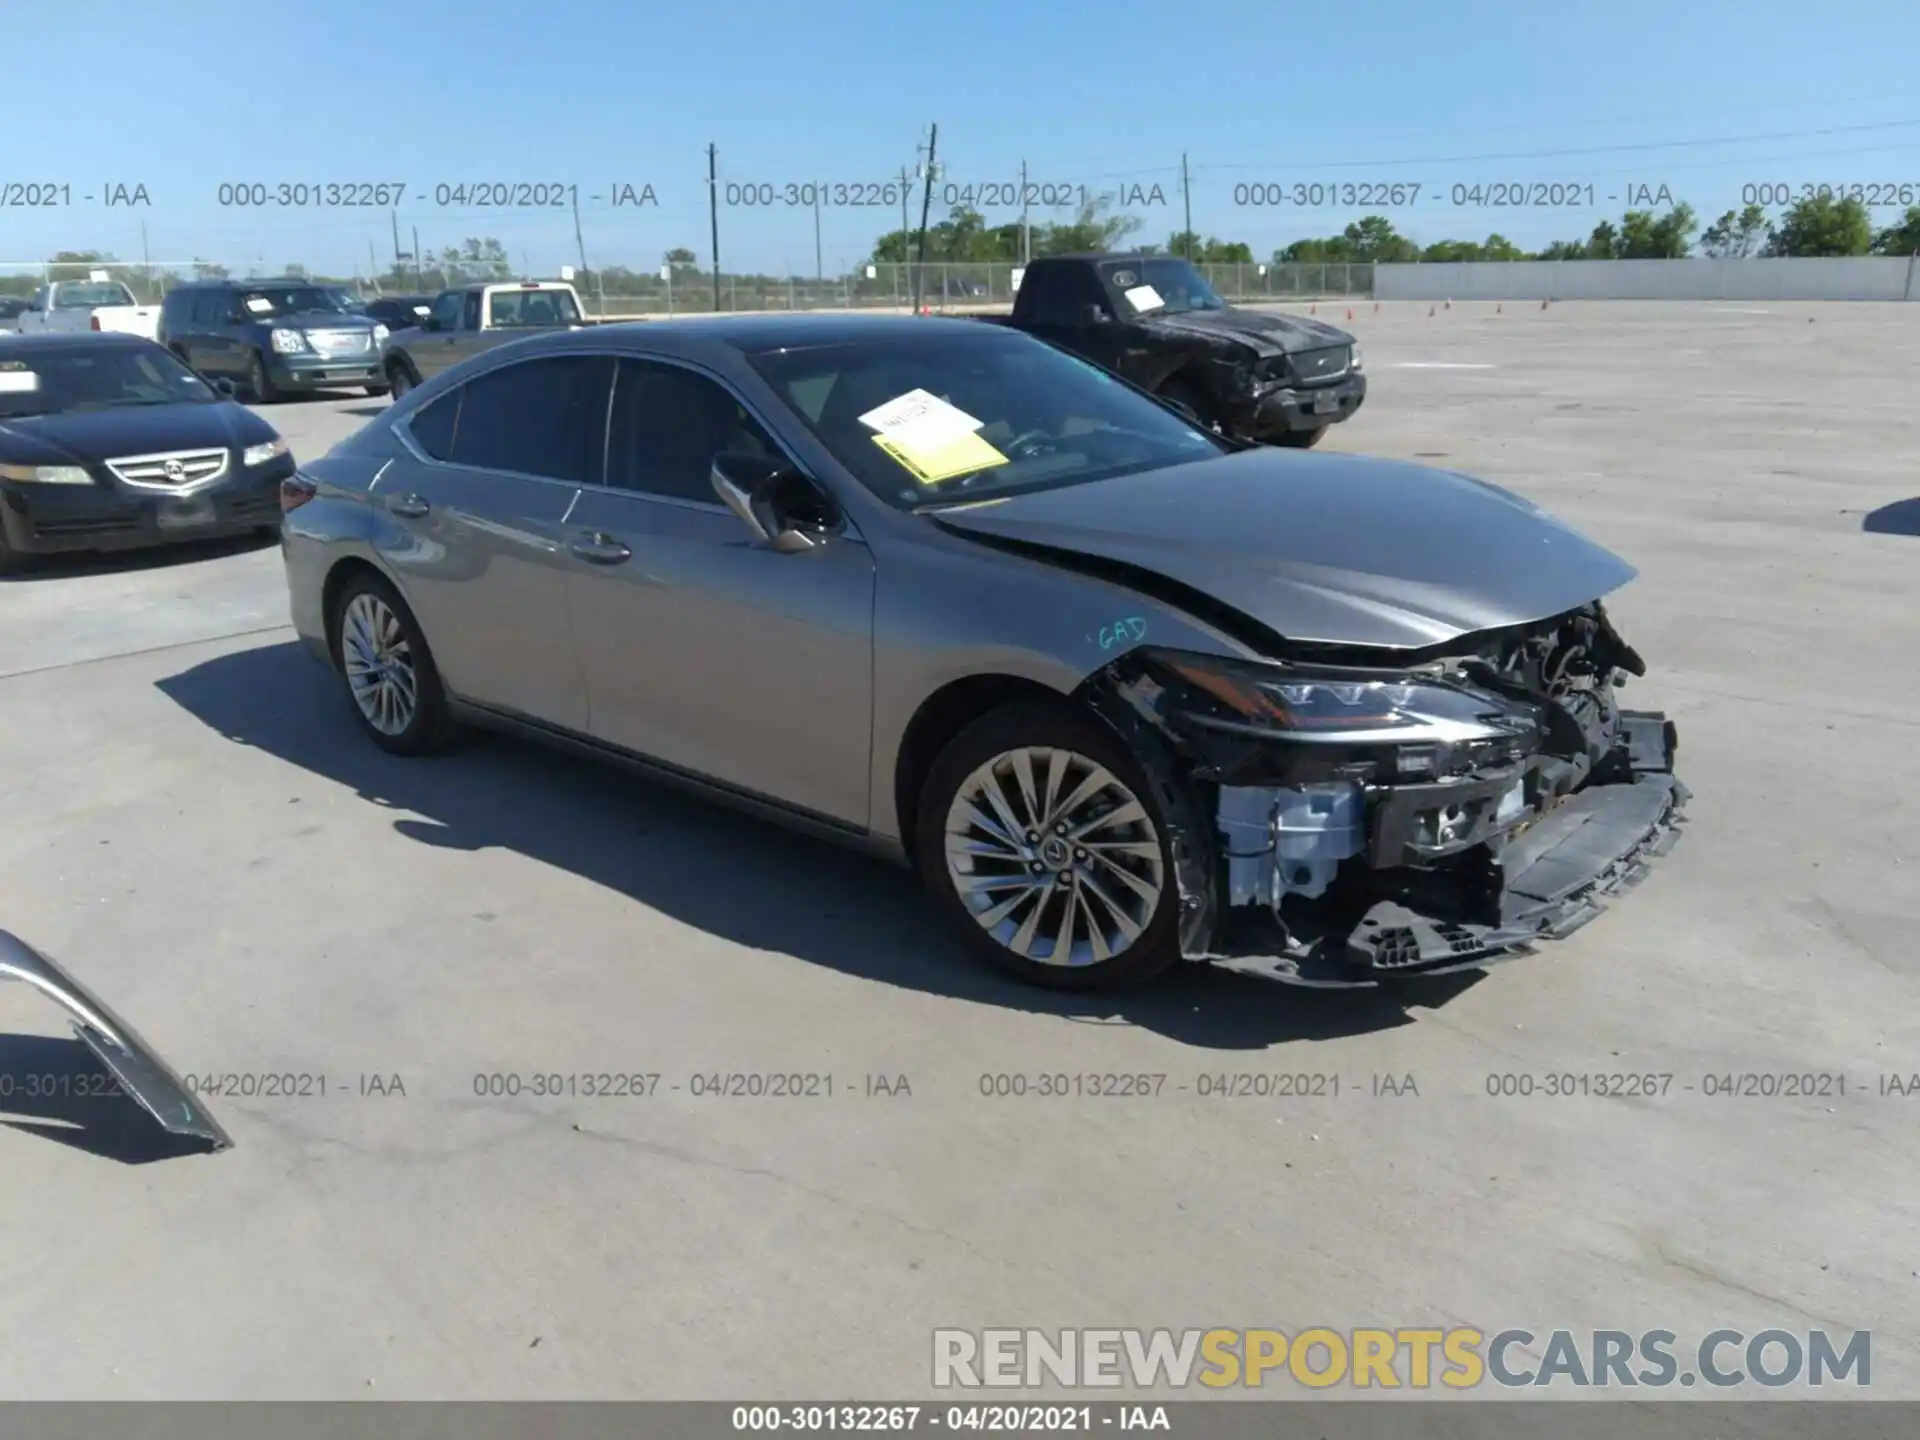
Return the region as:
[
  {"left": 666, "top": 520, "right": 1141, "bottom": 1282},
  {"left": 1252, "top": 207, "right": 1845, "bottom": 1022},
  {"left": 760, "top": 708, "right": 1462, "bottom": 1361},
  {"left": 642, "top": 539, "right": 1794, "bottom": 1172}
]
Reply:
[{"left": 1188, "top": 712, "right": 1690, "bottom": 989}]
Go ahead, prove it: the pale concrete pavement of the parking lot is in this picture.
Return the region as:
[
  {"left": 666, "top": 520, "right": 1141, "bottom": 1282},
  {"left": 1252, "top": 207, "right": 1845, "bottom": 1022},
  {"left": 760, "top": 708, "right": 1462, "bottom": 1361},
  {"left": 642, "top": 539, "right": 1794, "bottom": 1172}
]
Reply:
[{"left": 0, "top": 303, "right": 1920, "bottom": 1398}]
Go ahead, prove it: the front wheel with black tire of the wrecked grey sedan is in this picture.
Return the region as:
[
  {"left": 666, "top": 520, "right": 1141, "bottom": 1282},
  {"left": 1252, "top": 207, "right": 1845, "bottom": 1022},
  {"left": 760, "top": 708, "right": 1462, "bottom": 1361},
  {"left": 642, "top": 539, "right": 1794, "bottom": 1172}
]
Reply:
[{"left": 914, "top": 701, "right": 1179, "bottom": 991}]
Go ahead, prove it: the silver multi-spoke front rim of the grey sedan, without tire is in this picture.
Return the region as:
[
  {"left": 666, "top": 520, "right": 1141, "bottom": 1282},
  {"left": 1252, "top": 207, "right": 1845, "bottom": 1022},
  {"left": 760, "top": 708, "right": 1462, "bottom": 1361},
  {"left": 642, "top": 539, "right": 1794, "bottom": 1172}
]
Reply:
[{"left": 947, "top": 745, "right": 1165, "bottom": 966}]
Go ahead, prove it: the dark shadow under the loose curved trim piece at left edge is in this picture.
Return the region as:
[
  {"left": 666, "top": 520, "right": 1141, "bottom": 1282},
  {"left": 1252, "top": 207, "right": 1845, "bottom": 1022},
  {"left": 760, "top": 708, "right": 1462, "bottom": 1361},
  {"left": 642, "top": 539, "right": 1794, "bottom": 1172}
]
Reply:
[{"left": 0, "top": 1033, "right": 207, "bottom": 1165}]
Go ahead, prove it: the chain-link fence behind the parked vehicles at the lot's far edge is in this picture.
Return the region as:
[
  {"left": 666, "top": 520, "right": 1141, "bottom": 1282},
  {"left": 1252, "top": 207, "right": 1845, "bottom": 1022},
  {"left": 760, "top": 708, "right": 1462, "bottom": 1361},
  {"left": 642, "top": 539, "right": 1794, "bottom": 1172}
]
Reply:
[{"left": 0, "top": 259, "right": 1373, "bottom": 317}]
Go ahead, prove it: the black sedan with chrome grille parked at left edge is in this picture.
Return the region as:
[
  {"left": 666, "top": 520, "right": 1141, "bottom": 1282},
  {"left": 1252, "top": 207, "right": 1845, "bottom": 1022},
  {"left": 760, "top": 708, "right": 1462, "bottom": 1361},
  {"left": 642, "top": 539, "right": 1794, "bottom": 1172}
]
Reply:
[{"left": 0, "top": 334, "right": 294, "bottom": 572}]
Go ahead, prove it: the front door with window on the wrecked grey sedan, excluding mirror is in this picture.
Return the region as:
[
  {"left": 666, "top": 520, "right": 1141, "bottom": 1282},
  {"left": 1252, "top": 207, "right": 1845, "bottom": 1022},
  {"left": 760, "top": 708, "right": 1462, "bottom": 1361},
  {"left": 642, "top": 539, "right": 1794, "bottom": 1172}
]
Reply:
[{"left": 566, "top": 359, "right": 874, "bottom": 829}]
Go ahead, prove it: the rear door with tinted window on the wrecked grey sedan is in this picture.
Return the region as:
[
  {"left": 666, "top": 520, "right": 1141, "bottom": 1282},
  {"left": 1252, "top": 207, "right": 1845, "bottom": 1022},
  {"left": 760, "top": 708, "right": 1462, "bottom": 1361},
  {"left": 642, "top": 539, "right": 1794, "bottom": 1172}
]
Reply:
[{"left": 374, "top": 355, "right": 612, "bottom": 733}]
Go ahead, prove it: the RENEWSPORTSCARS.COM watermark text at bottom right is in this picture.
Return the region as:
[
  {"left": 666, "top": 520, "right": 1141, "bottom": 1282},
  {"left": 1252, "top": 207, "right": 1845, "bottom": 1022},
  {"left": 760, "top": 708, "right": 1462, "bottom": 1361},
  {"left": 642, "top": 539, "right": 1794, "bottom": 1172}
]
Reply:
[{"left": 933, "top": 1327, "right": 1874, "bottom": 1390}]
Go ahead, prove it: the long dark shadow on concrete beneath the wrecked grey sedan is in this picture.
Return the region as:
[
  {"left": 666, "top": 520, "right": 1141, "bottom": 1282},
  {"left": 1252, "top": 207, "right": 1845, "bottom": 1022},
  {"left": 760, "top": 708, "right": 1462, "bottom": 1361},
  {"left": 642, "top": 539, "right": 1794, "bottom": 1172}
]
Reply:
[{"left": 157, "top": 643, "right": 1478, "bottom": 1050}]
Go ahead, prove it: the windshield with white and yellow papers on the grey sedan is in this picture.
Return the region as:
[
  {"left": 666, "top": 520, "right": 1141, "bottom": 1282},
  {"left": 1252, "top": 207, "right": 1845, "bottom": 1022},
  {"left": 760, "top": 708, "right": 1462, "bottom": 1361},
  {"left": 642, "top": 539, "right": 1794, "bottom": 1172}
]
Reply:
[{"left": 747, "top": 324, "right": 1227, "bottom": 509}]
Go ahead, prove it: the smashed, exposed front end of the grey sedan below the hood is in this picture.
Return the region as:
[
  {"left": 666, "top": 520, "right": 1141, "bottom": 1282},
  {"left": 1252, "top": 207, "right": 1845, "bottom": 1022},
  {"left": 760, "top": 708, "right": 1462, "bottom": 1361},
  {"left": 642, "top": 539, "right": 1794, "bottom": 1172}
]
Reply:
[{"left": 1087, "top": 601, "right": 1688, "bottom": 985}]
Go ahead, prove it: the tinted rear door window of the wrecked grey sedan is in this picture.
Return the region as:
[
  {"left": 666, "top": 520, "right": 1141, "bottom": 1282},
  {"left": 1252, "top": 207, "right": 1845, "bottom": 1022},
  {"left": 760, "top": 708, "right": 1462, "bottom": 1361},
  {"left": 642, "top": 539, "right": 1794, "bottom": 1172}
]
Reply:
[{"left": 453, "top": 355, "right": 612, "bottom": 484}]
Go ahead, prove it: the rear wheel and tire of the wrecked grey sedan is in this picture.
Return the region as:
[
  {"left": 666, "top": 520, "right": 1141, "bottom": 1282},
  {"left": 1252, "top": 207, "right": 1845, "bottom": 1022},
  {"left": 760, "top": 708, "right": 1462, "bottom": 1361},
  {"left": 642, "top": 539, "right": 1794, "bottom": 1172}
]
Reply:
[{"left": 328, "top": 572, "right": 453, "bottom": 755}]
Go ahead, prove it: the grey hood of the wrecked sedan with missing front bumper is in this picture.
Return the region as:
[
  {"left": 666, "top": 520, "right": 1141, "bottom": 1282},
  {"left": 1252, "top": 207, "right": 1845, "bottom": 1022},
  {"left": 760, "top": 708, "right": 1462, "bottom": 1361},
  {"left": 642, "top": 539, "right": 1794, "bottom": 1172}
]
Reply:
[{"left": 931, "top": 447, "right": 1636, "bottom": 649}]
